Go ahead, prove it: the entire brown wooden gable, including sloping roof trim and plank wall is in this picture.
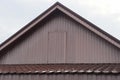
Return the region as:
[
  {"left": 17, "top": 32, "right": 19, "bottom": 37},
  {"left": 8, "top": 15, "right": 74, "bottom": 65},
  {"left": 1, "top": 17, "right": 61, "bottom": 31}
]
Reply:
[{"left": 0, "top": 2, "right": 120, "bottom": 64}]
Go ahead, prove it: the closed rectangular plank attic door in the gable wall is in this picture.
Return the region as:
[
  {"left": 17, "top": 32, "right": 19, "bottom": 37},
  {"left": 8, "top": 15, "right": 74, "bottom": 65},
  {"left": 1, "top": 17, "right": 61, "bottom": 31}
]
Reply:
[{"left": 48, "top": 32, "right": 66, "bottom": 63}]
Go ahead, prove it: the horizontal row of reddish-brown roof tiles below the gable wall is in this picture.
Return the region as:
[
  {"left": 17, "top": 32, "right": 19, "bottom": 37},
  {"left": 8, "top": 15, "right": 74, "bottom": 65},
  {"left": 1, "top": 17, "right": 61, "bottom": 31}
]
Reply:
[{"left": 0, "top": 63, "right": 120, "bottom": 74}]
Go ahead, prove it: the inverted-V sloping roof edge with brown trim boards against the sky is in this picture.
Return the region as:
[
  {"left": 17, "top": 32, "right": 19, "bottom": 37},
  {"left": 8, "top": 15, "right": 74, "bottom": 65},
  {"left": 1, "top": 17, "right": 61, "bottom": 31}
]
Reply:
[{"left": 0, "top": 2, "right": 120, "bottom": 54}]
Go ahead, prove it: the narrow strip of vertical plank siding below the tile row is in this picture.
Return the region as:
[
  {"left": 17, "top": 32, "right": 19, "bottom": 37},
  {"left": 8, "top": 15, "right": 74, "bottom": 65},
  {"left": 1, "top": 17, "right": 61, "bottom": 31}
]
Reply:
[{"left": 0, "top": 74, "right": 120, "bottom": 80}]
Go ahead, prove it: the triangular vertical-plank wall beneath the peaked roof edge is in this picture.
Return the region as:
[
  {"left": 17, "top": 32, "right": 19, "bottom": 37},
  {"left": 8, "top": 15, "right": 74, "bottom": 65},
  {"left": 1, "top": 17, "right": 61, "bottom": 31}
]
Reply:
[{"left": 0, "top": 13, "right": 120, "bottom": 64}]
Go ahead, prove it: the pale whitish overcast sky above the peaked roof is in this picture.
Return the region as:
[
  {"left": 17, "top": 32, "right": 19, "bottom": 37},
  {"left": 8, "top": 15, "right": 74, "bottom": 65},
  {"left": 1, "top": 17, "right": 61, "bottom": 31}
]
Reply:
[{"left": 0, "top": 0, "right": 120, "bottom": 43}]
